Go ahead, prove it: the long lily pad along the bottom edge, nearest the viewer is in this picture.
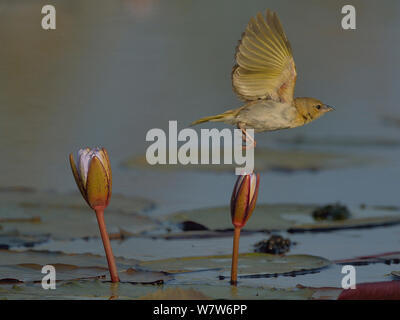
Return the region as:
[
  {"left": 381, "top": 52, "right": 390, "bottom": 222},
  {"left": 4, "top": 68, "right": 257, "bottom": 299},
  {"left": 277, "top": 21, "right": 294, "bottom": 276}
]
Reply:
[{"left": 0, "top": 279, "right": 316, "bottom": 300}]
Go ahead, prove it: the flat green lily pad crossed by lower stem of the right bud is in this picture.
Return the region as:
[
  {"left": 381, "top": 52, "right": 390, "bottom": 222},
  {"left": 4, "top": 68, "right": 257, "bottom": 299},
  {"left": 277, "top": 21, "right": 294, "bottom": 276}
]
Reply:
[{"left": 139, "top": 253, "right": 331, "bottom": 277}]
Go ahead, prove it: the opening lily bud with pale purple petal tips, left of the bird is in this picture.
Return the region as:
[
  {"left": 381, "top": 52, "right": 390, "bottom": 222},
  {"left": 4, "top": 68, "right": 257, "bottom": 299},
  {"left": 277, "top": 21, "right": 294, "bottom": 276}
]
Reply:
[{"left": 69, "top": 148, "right": 112, "bottom": 210}]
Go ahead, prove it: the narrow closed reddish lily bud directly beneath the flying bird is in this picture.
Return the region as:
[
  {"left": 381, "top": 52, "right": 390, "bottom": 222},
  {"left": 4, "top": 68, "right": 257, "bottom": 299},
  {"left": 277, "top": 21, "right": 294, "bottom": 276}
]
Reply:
[{"left": 231, "top": 173, "right": 260, "bottom": 228}]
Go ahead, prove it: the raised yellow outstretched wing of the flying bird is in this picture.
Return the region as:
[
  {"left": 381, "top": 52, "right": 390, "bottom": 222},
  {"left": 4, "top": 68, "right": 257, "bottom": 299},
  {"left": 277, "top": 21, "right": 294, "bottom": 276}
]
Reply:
[{"left": 232, "top": 10, "right": 297, "bottom": 103}]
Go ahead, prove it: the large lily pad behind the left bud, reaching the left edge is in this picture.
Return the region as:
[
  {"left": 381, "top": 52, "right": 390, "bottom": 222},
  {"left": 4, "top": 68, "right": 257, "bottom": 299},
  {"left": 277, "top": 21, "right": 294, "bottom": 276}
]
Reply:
[{"left": 0, "top": 192, "right": 158, "bottom": 240}]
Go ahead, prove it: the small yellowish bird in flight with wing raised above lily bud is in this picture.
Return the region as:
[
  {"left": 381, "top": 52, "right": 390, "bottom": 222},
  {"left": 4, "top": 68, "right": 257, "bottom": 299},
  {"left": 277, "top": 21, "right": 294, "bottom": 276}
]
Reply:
[{"left": 191, "top": 9, "right": 334, "bottom": 148}]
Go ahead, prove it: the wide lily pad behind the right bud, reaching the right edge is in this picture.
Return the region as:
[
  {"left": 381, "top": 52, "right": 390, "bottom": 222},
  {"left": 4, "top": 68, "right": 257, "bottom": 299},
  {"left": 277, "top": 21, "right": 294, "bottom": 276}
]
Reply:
[{"left": 166, "top": 204, "right": 400, "bottom": 232}]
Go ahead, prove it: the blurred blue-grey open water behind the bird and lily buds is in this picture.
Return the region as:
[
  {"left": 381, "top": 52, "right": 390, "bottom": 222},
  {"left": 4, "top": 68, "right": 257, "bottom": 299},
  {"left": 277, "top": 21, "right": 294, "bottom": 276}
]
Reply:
[{"left": 0, "top": 0, "right": 400, "bottom": 213}]
